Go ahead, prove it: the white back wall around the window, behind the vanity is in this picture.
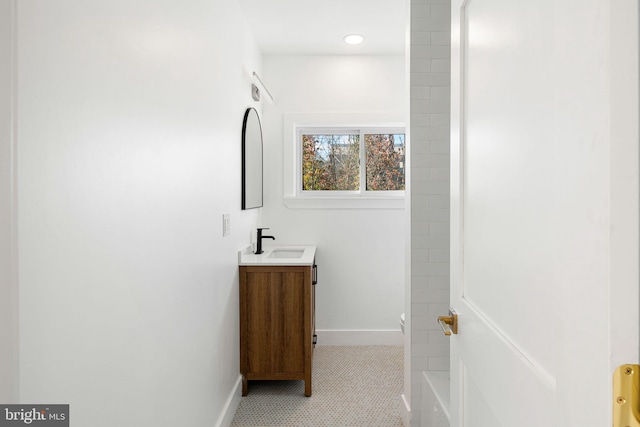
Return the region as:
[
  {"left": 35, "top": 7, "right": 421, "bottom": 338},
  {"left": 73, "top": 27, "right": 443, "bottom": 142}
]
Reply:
[{"left": 263, "top": 55, "right": 408, "bottom": 338}]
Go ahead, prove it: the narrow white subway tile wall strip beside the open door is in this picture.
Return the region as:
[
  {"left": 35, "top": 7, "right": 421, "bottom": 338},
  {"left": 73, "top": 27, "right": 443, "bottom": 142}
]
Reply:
[{"left": 410, "top": 0, "right": 451, "bottom": 426}]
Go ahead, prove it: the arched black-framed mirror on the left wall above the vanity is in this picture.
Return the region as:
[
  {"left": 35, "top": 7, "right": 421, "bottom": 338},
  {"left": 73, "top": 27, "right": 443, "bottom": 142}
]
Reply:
[{"left": 242, "top": 107, "right": 262, "bottom": 209}]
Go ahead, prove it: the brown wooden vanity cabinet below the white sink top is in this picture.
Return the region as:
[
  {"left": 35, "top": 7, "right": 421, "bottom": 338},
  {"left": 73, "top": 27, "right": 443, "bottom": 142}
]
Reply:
[{"left": 240, "top": 264, "right": 316, "bottom": 396}]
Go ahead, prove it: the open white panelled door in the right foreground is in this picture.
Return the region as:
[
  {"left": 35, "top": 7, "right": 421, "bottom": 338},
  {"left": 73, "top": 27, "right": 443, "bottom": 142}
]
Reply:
[{"left": 450, "top": 0, "right": 639, "bottom": 427}]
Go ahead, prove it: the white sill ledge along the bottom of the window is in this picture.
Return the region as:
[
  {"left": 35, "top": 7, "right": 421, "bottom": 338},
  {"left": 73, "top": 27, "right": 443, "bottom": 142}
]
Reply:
[{"left": 283, "top": 196, "right": 405, "bottom": 210}]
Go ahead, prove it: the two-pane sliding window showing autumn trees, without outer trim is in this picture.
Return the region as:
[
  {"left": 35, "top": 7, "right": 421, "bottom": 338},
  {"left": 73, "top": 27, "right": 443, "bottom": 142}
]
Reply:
[{"left": 297, "top": 127, "right": 405, "bottom": 196}]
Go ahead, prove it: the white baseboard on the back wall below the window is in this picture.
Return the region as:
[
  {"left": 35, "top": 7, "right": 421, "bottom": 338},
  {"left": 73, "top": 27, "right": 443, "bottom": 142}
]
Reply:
[{"left": 316, "top": 329, "right": 404, "bottom": 346}]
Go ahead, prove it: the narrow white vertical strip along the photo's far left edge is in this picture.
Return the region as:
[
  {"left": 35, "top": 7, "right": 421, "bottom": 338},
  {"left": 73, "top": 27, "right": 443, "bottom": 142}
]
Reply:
[{"left": 0, "top": 0, "right": 18, "bottom": 403}]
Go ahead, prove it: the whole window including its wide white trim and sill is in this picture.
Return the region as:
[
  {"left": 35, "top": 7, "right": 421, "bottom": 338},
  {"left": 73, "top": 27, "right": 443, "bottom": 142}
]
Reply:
[{"left": 283, "top": 112, "right": 408, "bottom": 209}]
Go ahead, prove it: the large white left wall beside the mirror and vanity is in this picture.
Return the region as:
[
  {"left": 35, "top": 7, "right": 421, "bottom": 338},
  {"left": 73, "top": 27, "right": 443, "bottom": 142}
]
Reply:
[{"left": 15, "top": 0, "right": 261, "bottom": 427}]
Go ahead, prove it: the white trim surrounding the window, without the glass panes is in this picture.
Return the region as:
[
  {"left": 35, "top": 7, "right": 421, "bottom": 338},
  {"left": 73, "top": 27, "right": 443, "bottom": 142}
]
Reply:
[{"left": 283, "top": 113, "right": 408, "bottom": 209}]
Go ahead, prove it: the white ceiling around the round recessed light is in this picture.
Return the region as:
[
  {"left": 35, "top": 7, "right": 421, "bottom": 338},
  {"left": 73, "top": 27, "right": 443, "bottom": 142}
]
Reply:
[{"left": 240, "top": 0, "right": 408, "bottom": 55}]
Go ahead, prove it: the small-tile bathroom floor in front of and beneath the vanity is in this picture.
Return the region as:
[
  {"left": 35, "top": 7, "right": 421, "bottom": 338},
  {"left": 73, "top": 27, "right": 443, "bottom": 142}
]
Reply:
[{"left": 231, "top": 346, "right": 404, "bottom": 427}]
